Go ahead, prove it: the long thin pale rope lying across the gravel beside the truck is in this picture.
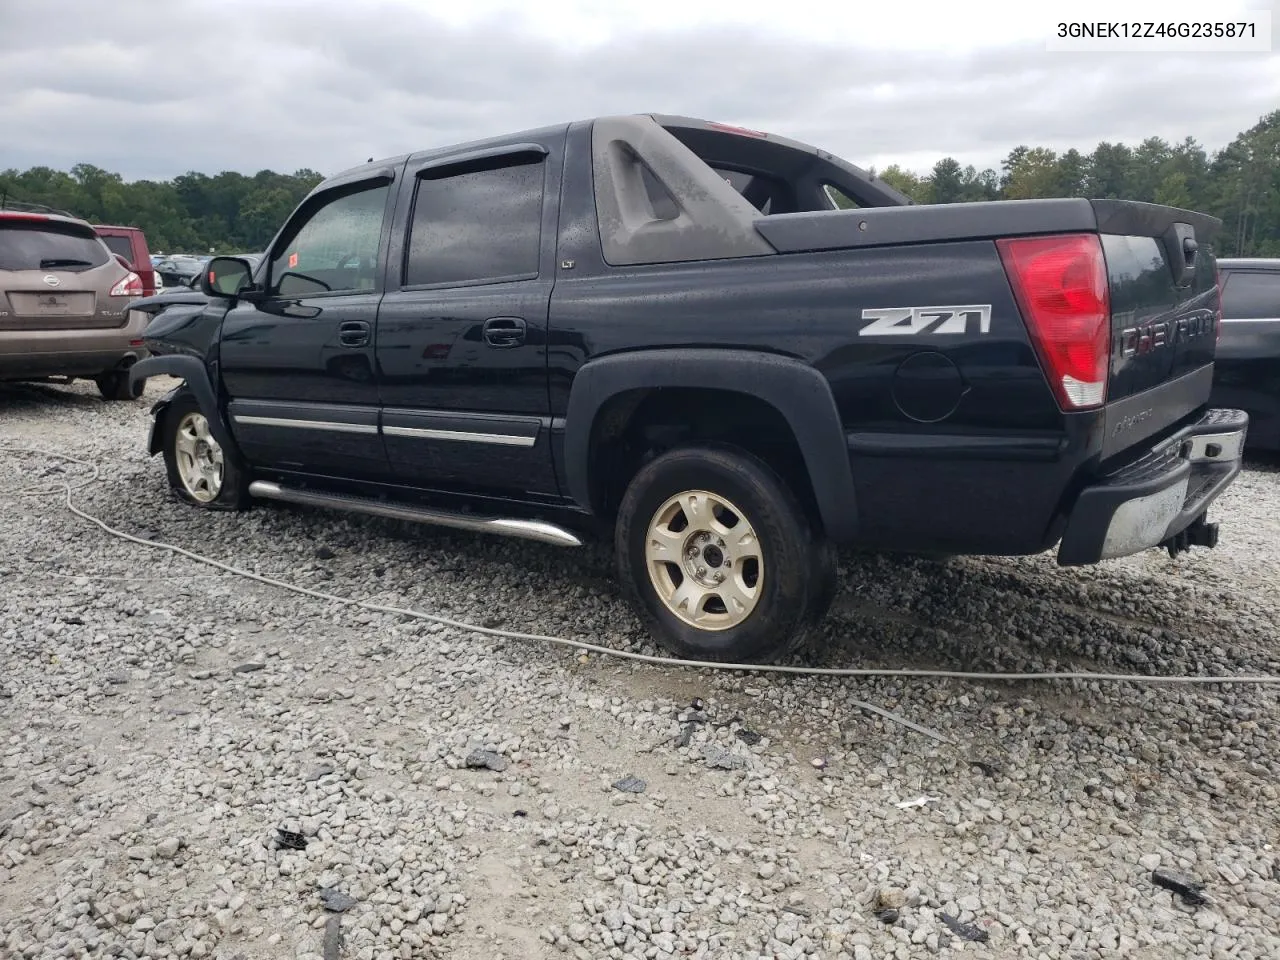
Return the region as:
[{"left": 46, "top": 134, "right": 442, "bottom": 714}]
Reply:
[{"left": 0, "top": 440, "right": 1280, "bottom": 744}]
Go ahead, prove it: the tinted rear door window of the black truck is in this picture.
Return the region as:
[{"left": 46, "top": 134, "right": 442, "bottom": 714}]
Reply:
[{"left": 404, "top": 155, "right": 545, "bottom": 287}]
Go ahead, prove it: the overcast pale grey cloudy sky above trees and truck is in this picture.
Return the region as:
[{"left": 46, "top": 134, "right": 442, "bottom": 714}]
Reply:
[{"left": 0, "top": 0, "right": 1280, "bottom": 179}]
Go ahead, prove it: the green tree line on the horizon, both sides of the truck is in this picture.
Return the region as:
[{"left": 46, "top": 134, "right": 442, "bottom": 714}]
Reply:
[{"left": 0, "top": 110, "right": 1280, "bottom": 256}]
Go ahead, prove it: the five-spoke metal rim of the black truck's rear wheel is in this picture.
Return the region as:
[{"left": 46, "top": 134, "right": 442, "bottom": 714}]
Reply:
[{"left": 645, "top": 490, "right": 764, "bottom": 630}]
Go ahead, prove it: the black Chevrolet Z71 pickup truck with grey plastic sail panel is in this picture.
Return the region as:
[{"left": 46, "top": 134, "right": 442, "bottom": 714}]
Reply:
[{"left": 133, "top": 115, "right": 1248, "bottom": 662}]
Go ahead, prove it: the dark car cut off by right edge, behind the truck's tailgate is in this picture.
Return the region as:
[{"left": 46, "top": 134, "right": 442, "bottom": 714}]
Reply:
[{"left": 1212, "top": 259, "right": 1280, "bottom": 451}]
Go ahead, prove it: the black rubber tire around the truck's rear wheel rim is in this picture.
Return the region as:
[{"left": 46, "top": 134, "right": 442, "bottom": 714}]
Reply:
[{"left": 614, "top": 447, "right": 836, "bottom": 663}]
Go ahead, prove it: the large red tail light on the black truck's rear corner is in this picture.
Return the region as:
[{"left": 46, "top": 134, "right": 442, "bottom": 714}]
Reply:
[{"left": 996, "top": 233, "right": 1111, "bottom": 411}]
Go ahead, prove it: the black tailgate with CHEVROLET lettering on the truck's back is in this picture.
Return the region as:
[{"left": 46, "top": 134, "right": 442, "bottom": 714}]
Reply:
[{"left": 1091, "top": 200, "right": 1221, "bottom": 460}]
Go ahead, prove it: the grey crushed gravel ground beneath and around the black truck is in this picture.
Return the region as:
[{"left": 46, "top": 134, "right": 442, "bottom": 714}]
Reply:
[{"left": 0, "top": 383, "right": 1280, "bottom": 960}]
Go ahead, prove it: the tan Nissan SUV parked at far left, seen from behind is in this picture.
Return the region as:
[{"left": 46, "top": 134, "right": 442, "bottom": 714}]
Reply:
[{"left": 0, "top": 211, "right": 146, "bottom": 399}]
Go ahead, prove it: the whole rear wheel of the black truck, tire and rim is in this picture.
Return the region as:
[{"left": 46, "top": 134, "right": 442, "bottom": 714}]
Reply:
[{"left": 616, "top": 447, "right": 835, "bottom": 663}]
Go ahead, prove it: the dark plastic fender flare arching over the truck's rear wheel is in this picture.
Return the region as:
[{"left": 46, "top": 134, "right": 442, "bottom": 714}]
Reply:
[{"left": 564, "top": 349, "right": 858, "bottom": 541}]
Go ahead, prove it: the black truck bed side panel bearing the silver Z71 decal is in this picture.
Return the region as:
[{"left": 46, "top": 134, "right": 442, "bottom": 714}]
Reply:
[{"left": 548, "top": 232, "right": 1085, "bottom": 554}]
